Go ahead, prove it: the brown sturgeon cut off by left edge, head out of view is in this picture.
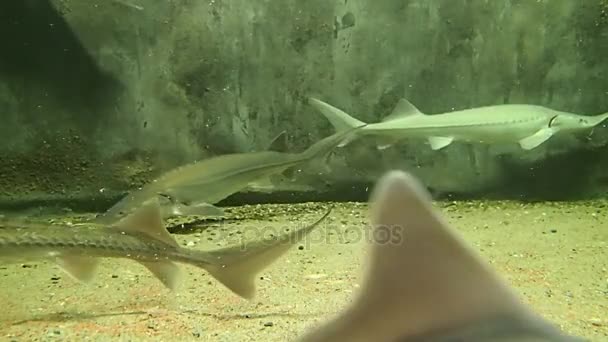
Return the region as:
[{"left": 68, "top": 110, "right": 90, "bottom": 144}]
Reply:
[{"left": 0, "top": 200, "right": 329, "bottom": 298}]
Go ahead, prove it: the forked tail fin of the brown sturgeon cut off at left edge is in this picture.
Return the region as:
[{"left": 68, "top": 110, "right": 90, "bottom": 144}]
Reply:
[{"left": 205, "top": 209, "right": 331, "bottom": 299}]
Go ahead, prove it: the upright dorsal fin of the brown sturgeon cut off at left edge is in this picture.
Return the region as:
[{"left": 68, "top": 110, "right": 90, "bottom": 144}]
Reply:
[{"left": 112, "top": 197, "right": 178, "bottom": 246}]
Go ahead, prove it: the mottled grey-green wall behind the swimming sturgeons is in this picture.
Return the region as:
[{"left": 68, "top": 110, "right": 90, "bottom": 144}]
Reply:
[{"left": 0, "top": 0, "right": 608, "bottom": 210}]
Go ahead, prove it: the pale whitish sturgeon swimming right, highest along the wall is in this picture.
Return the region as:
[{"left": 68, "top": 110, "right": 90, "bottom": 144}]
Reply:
[{"left": 309, "top": 98, "right": 608, "bottom": 150}]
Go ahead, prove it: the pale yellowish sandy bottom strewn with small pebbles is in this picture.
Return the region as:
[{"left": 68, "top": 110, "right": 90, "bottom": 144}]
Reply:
[{"left": 0, "top": 202, "right": 608, "bottom": 341}]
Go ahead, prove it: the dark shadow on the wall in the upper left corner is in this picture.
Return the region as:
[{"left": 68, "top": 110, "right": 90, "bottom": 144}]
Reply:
[{"left": 0, "top": 0, "right": 123, "bottom": 128}]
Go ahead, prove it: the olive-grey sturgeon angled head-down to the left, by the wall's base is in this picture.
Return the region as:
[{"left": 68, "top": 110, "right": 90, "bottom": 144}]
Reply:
[{"left": 96, "top": 128, "right": 357, "bottom": 224}]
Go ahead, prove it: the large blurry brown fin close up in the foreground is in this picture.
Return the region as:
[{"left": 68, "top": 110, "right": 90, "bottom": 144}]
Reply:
[{"left": 300, "top": 171, "right": 579, "bottom": 342}]
